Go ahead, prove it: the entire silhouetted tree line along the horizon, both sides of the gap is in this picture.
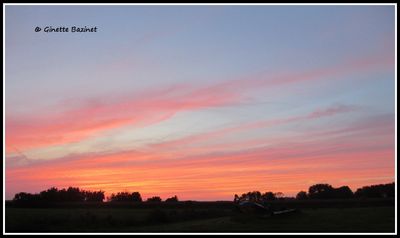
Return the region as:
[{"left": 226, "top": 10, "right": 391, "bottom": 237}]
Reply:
[{"left": 13, "top": 182, "right": 395, "bottom": 203}]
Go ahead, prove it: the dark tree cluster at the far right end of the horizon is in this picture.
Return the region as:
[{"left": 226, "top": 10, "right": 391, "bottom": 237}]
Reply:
[{"left": 354, "top": 183, "right": 395, "bottom": 198}]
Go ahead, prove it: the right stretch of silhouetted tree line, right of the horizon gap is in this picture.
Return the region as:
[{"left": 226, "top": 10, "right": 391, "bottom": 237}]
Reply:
[{"left": 233, "top": 182, "right": 395, "bottom": 203}]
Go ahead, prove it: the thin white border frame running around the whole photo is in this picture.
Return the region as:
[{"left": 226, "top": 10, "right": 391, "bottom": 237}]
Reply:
[{"left": 3, "top": 3, "right": 397, "bottom": 235}]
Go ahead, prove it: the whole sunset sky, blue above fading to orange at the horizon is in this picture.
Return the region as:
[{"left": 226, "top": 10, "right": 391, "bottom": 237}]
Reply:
[{"left": 4, "top": 5, "right": 395, "bottom": 200}]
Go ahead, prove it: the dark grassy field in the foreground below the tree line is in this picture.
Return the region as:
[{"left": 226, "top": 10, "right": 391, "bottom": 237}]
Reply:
[{"left": 6, "top": 201, "right": 395, "bottom": 232}]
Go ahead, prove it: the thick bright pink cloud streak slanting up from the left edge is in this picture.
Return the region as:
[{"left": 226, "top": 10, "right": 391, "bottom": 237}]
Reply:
[{"left": 6, "top": 82, "right": 238, "bottom": 150}]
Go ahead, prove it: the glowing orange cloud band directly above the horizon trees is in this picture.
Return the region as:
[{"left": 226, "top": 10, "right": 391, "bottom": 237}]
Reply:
[{"left": 6, "top": 144, "right": 394, "bottom": 199}]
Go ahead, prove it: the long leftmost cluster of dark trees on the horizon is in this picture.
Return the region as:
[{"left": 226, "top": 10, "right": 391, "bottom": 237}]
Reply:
[{"left": 13, "top": 187, "right": 104, "bottom": 202}]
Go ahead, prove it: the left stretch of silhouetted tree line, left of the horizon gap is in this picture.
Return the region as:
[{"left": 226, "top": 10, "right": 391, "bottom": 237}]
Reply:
[{"left": 13, "top": 187, "right": 178, "bottom": 202}]
